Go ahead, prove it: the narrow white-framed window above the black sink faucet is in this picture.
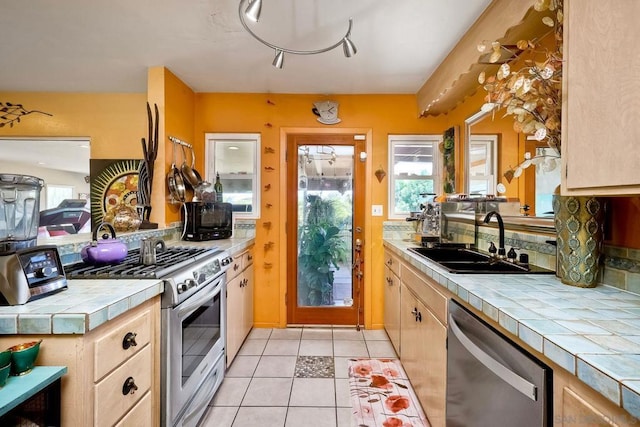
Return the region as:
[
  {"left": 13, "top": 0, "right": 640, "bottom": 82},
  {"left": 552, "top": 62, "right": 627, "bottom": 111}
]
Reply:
[{"left": 469, "top": 135, "right": 498, "bottom": 195}]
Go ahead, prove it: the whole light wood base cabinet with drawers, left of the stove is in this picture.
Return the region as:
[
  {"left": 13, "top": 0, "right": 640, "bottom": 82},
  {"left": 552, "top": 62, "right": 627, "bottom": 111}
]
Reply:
[{"left": 0, "top": 296, "right": 160, "bottom": 426}]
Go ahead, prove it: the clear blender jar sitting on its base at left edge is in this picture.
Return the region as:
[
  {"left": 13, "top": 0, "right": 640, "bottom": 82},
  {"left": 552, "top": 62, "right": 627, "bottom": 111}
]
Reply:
[{"left": 0, "top": 174, "right": 44, "bottom": 255}]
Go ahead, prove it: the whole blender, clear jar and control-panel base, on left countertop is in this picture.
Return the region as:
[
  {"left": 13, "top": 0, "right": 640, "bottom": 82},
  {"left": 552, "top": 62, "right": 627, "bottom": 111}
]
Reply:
[{"left": 0, "top": 174, "right": 67, "bottom": 305}]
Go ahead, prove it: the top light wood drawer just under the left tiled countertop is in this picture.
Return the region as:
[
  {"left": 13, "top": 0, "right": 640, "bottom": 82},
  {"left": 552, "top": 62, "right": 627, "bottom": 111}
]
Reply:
[{"left": 93, "top": 310, "right": 152, "bottom": 382}]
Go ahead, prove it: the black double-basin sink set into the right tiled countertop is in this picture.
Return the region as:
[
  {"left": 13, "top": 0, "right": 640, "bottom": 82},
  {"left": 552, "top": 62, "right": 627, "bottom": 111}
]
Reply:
[{"left": 409, "top": 247, "right": 554, "bottom": 274}]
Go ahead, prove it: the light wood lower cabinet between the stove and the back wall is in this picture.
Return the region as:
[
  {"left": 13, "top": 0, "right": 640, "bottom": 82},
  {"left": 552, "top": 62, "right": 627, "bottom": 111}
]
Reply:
[{"left": 225, "top": 246, "right": 254, "bottom": 366}]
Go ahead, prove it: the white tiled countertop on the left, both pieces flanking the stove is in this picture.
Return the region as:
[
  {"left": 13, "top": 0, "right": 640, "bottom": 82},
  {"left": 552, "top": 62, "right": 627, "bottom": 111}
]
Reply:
[{"left": 0, "top": 238, "right": 254, "bottom": 335}]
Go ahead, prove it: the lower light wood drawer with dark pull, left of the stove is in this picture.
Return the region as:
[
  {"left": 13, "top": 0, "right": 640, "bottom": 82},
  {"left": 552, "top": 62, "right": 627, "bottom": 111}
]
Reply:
[{"left": 94, "top": 344, "right": 153, "bottom": 426}]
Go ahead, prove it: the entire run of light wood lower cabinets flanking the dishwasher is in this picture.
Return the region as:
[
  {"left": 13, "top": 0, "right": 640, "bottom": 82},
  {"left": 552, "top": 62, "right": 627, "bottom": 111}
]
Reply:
[{"left": 385, "top": 251, "right": 638, "bottom": 427}]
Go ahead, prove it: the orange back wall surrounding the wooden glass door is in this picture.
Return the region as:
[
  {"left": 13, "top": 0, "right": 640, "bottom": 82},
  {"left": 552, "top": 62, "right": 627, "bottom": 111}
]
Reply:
[{"left": 194, "top": 93, "right": 445, "bottom": 328}]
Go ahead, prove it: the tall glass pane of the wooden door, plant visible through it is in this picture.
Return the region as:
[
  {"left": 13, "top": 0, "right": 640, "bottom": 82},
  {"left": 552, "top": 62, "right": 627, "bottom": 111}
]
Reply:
[{"left": 297, "top": 145, "right": 354, "bottom": 307}]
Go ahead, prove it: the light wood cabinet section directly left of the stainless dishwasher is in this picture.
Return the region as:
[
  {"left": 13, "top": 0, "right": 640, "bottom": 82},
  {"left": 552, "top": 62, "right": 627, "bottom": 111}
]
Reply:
[{"left": 400, "top": 266, "right": 447, "bottom": 427}]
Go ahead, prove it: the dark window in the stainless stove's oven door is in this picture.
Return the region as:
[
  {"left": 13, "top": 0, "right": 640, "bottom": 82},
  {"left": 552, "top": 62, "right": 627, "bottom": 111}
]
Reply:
[{"left": 182, "top": 293, "right": 221, "bottom": 385}]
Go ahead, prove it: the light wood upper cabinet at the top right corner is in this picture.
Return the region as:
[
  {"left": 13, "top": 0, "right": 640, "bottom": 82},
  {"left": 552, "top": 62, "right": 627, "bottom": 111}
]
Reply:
[{"left": 562, "top": 0, "right": 640, "bottom": 195}]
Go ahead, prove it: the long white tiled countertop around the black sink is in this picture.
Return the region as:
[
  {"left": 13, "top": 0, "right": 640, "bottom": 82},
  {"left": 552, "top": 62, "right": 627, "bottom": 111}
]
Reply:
[{"left": 384, "top": 240, "right": 640, "bottom": 418}]
